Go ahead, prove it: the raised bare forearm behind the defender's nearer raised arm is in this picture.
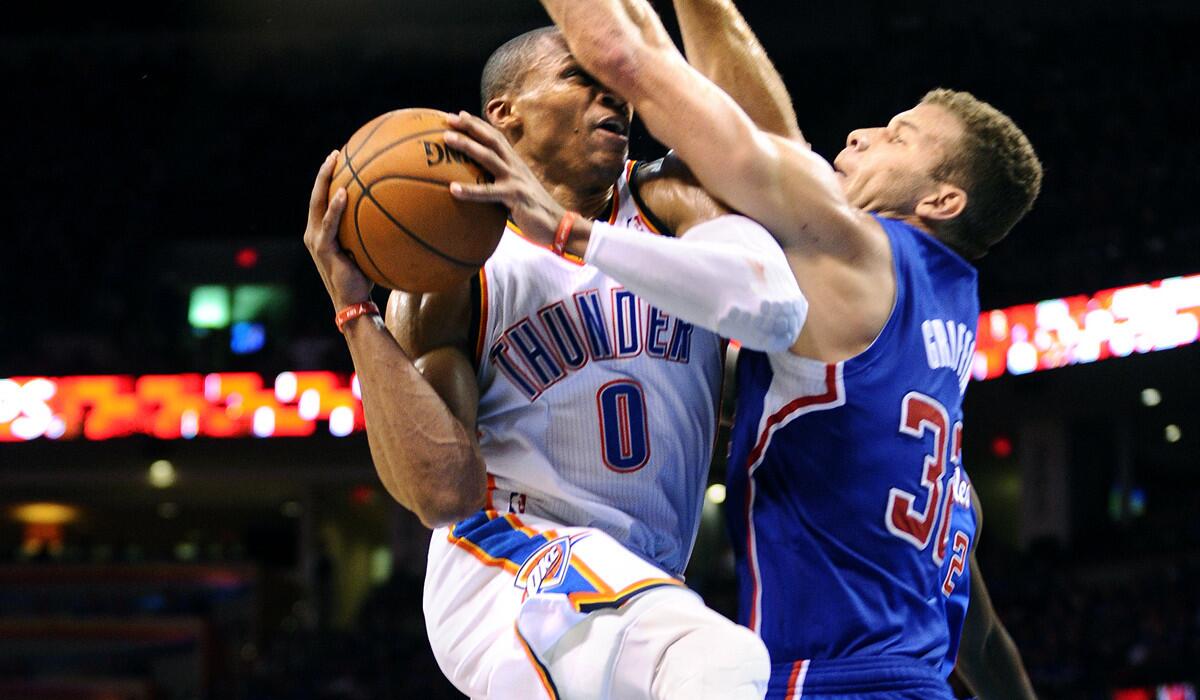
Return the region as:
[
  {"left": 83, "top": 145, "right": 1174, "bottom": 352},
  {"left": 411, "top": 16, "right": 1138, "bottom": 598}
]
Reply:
[{"left": 674, "top": 0, "right": 804, "bottom": 140}]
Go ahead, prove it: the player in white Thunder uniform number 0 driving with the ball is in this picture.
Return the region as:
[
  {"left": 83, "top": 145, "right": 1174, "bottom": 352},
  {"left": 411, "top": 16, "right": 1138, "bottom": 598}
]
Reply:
[{"left": 305, "top": 17, "right": 798, "bottom": 699}]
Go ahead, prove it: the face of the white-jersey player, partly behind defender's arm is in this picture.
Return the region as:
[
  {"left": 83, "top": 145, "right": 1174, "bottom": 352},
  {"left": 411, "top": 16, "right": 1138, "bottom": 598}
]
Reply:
[{"left": 512, "top": 38, "right": 634, "bottom": 181}]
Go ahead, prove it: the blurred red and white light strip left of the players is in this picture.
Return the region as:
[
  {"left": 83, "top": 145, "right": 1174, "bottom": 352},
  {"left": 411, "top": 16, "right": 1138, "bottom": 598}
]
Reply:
[{"left": 0, "top": 372, "right": 364, "bottom": 442}]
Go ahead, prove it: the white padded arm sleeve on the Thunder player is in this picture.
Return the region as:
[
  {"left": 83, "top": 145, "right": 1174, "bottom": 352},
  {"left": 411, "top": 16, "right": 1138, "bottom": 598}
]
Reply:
[{"left": 583, "top": 214, "right": 809, "bottom": 352}]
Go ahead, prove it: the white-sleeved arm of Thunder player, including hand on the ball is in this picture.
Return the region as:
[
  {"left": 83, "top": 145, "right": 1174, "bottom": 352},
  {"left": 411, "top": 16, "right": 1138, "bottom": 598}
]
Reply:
[{"left": 444, "top": 113, "right": 808, "bottom": 352}]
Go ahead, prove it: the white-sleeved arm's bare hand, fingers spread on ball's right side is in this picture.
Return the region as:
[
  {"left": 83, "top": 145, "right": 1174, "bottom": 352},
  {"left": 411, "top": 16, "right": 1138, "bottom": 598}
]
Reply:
[{"left": 443, "top": 112, "right": 566, "bottom": 240}]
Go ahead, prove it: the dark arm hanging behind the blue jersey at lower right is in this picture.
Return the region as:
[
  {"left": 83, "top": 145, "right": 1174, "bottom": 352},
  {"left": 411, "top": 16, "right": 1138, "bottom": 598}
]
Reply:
[{"left": 955, "top": 489, "right": 1036, "bottom": 700}]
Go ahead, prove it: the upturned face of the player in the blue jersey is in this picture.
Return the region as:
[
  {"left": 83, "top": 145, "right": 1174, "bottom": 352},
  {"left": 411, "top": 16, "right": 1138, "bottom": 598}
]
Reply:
[{"left": 833, "top": 104, "right": 962, "bottom": 214}]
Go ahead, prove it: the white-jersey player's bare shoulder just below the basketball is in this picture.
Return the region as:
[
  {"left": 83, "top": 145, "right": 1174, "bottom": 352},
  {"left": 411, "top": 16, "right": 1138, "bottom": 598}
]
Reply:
[{"left": 384, "top": 280, "right": 476, "bottom": 358}]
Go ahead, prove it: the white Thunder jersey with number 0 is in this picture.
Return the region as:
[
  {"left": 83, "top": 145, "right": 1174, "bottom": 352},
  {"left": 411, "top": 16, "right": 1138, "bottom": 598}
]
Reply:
[{"left": 478, "top": 161, "right": 721, "bottom": 576}]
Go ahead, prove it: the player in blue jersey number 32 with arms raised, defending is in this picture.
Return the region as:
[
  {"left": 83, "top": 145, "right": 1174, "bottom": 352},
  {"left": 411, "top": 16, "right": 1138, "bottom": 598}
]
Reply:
[{"left": 511, "top": 0, "right": 1042, "bottom": 699}]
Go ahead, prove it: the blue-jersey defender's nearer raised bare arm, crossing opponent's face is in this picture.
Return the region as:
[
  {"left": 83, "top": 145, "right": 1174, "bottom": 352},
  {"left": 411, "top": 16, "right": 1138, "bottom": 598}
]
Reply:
[{"left": 542, "top": 0, "right": 875, "bottom": 258}]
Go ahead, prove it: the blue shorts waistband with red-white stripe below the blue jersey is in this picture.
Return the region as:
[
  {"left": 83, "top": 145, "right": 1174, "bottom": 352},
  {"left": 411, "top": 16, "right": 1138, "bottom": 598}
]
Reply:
[{"left": 770, "top": 656, "right": 953, "bottom": 698}]
